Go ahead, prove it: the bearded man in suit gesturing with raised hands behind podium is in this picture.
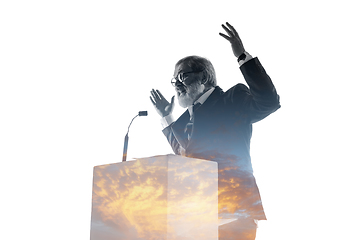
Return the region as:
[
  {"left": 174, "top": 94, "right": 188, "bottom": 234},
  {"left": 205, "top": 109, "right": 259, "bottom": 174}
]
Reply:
[{"left": 150, "top": 23, "right": 280, "bottom": 240}]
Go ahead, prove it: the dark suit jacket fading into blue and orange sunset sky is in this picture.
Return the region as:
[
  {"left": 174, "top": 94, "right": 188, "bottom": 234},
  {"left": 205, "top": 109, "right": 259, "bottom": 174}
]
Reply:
[{"left": 163, "top": 58, "right": 280, "bottom": 220}]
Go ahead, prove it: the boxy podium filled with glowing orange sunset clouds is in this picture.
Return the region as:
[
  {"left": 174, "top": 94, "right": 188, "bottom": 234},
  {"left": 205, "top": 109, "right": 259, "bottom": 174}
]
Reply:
[{"left": 90, "top": 155, "right": 218, "bottom": 240}]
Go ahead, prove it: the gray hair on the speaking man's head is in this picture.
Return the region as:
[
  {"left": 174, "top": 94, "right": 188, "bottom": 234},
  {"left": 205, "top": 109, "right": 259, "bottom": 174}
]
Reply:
[{"left": 175, "top": 56, "right": 217, "bottom": 87}]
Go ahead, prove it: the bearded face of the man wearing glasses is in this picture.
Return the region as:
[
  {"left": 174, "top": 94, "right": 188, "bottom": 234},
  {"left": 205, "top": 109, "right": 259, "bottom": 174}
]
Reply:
[{"left": 174, "top": 64, "right": 205, "bottom": 108}]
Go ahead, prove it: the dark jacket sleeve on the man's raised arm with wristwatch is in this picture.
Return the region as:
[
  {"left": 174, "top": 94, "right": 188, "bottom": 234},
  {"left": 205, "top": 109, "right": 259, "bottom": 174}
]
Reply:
[{"left": 240, "top": 58, "right": 280, "bottom": 123}]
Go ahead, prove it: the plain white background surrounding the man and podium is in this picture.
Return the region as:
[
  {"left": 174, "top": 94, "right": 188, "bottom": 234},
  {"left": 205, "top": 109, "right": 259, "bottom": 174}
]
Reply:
[{"left": 0, "top": 0, "right": 360, "bottom": 240}]
